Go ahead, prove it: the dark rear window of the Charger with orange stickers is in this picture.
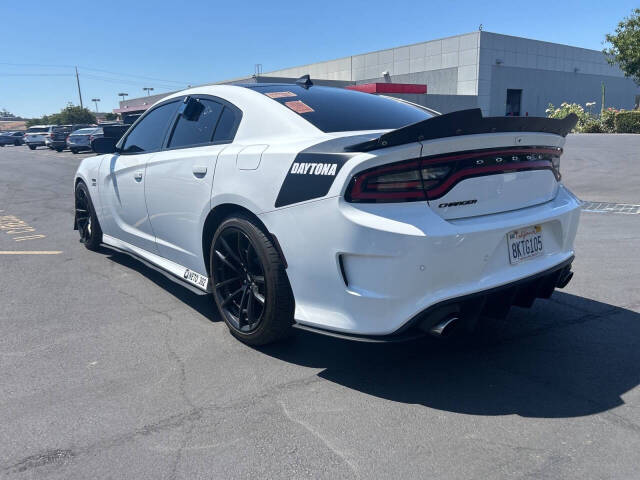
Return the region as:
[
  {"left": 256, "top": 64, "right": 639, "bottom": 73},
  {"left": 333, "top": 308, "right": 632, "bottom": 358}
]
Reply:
[{"left": 247, "top": 84, "right": 432, "bottom": 132}]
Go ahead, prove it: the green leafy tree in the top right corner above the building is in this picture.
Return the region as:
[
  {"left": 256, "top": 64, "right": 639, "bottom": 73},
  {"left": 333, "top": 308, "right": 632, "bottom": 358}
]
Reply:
[{"left": 603, "top": 8, "right": 640, "bottom": 85}]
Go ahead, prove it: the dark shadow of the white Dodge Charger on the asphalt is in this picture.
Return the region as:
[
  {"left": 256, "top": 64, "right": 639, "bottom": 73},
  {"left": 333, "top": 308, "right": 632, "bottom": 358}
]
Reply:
[{"left": 96, "top": 249, "right": 640, "bottom": 421}]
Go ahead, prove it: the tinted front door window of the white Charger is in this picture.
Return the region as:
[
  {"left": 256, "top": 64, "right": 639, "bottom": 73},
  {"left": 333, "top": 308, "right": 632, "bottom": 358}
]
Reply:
[{"left": 122, "top": 101, "right": 180, "bottom": 153}]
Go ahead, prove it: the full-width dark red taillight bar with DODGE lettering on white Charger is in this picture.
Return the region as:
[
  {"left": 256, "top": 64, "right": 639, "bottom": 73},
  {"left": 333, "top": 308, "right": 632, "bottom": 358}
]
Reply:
[{"left": 345, "top": 147, "right": 562, "bottom": 203}]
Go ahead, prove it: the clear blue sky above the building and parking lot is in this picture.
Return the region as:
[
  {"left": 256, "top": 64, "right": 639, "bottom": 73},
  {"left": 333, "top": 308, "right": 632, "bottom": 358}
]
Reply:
[{"left": 0, "top": 0, "right": 638, "bottom": 117}]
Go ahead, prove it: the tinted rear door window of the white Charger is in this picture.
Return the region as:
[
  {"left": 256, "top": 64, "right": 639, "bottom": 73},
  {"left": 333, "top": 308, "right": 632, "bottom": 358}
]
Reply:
[{"left": 168, "top": 99, "right": 223, "bottom": 148}]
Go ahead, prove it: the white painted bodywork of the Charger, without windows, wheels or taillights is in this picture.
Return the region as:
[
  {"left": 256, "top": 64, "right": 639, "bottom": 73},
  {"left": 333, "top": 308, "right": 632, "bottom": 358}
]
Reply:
[{"left": 76, "top": 85, "right": 580, "bottom": 335}]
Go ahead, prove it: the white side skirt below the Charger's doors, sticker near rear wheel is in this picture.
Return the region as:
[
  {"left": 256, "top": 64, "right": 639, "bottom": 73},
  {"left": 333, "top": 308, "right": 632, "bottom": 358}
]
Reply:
[{"left": 102, "top": 234, "right": 211, "bottom": 295}]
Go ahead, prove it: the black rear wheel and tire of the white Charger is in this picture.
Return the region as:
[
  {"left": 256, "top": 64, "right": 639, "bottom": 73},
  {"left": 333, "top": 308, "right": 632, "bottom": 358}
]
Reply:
[{"left": 209, "top": 214, "right": 295, "bottom": 346}]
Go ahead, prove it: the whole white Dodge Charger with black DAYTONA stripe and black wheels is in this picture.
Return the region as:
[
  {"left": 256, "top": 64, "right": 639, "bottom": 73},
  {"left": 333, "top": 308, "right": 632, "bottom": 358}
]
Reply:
[{"left": 74, "top": 77, "right": 580, "bottom": 345}]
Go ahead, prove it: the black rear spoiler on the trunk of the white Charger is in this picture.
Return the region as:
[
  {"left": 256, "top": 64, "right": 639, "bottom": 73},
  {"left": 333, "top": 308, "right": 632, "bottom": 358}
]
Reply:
[{"left": 345, "top": 108, "right": 578, "bottom": 152}]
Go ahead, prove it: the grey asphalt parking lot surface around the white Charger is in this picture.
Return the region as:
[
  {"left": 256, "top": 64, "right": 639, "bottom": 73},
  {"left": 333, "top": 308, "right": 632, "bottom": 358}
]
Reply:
[{"left": 0, "top": 135, "right": 640, "bottom": 479}]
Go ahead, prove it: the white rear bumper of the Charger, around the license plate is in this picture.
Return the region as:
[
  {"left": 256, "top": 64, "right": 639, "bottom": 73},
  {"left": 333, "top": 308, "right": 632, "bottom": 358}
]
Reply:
[{"left": 261, "top": 186, "right": 580, "bottom": 336}]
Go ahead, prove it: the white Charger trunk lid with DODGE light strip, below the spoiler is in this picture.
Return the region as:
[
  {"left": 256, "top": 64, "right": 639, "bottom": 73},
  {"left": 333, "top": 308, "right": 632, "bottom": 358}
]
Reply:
[{"left": 421, "top": 133, "right": 564, "bottom": 220}]
